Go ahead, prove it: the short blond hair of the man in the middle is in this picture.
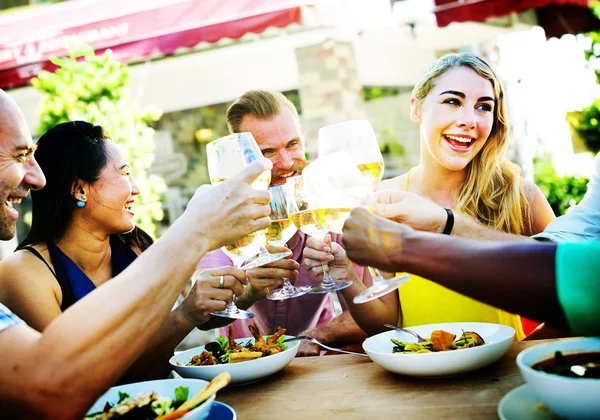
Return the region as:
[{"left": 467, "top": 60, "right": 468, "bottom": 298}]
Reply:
[{"left": 225, "top": 90, "right": 300, "bottom": 133}]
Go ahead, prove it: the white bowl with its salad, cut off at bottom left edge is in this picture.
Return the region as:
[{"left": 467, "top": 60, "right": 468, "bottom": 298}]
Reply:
[{"left": 86, "top": 379, "right": 215, "bottom": 420}]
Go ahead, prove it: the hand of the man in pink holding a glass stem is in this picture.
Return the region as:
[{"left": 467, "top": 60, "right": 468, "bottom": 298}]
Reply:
[{"left": 246, "top": 245, "right": 300, "bottom": 303}]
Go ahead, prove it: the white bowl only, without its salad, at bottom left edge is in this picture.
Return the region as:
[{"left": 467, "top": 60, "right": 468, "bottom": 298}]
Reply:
[{"left": 88, "top": 379, "right": 215, "bottom": 420}]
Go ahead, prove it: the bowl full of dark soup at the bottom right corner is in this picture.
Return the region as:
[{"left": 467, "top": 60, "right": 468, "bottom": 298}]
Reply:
[{"left": 517, "top": 338, "right": 600, "bottom": 419}]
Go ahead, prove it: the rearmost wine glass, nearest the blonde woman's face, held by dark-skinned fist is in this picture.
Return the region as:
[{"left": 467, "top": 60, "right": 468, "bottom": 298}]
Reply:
[{"left": 317, "top": 120, "right": 410, "bottom": 303}]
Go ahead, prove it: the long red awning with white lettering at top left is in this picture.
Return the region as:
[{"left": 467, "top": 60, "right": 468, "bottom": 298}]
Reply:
[{"left": 0, "top": 0, "right": 318, "bottom": 88}]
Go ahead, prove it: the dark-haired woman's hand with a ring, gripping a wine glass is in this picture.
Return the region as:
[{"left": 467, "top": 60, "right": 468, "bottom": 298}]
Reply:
[{"left": 180, "top": 267, "right": 248, "bottom": 325}]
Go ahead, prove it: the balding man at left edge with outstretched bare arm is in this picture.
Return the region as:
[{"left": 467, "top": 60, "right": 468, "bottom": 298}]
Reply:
[{"left": 0, "top": 90, "right": 272, "bottom": 420}]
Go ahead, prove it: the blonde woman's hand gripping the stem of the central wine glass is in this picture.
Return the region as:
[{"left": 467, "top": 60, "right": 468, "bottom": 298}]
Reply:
[{"left": 303, "top": 235, "right": 355, "bottom": 283}]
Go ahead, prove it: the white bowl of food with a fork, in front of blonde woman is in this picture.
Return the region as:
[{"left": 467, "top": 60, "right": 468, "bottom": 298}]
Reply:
[{"left": 363, "top": 322, "right": 515, "bottom": 377}]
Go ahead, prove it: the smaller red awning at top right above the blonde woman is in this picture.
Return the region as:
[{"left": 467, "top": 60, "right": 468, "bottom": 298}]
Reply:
[{"left": 435, "top": 0, "right": 588, "bottom": 27}]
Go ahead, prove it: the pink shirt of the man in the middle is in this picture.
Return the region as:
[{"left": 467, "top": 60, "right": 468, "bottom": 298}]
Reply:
[{"left": 198, "top": 232, "right": 364, "bottom": 338}]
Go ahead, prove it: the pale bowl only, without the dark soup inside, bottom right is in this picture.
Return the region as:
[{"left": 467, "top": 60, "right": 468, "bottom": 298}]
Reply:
[{"left": 517, "top": 338, "right": 600, "bottom": 419}]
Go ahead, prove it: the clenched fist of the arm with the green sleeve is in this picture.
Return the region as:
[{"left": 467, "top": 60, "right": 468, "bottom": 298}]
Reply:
[{"left": 342, "top": 208, "right": 414, "bottom": 272}]
